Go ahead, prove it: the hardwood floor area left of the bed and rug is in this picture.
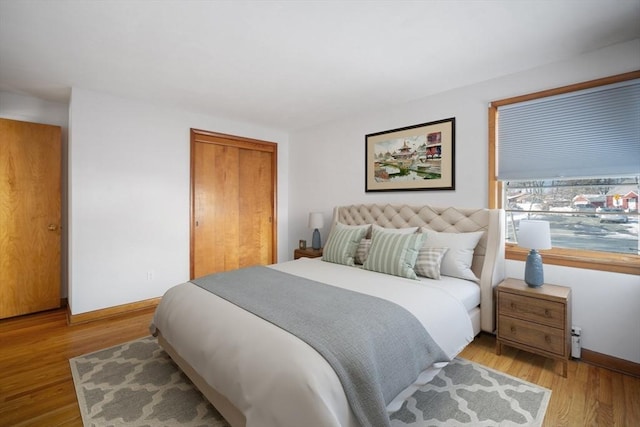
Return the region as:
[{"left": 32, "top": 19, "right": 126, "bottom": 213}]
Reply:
[{"left": 0, "top": 309, "right": 153, "bottom": 426}]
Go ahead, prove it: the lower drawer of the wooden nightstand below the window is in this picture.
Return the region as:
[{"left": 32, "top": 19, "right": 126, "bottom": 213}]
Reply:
[{"left": 498, "top": 315, "right": 567, "bottom": 357}]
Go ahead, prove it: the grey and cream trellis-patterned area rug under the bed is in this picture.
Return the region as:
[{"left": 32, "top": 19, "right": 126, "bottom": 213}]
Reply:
[{"left": 69, "top": 337, "right": 551, "bottom": 427}]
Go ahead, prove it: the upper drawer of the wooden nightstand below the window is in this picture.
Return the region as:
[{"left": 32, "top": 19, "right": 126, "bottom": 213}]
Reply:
[{"left": 499, "top": 292, "right": 565, "bottom": 328}]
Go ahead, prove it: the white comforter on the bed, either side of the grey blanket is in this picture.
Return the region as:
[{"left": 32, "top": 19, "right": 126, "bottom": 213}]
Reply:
[{"left": 151, "top": 258, "right": 473, "bottom": 427}]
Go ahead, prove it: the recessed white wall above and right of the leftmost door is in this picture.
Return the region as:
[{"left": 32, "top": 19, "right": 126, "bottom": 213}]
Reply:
[{"left": 0, "top": 92, "right": 69, "bottom": 298}]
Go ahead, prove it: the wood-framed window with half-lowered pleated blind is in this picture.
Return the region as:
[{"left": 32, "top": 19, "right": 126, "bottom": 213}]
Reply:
[{"left": 489, "top": 71, "right": 640, "bottom": 274}]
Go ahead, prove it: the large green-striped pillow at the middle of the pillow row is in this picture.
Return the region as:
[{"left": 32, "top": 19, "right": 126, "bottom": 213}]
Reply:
[{"left": 363, "top": 230, "right": 424, "bottom": 279}]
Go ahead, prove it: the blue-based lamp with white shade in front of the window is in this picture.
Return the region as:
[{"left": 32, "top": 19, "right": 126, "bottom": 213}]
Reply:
[{"left": 518, "top": 220, "right": 551, "bottom": 288}]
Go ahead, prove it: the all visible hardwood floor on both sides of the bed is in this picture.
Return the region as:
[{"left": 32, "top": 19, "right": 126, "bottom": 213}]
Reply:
[{"left": 0, "top": 309, "right": 640, "bottom": 427}]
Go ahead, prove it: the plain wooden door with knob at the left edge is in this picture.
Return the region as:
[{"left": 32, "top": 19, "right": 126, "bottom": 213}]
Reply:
[{"left": 0, "top": 119, "right": 61, "bottom": 318}]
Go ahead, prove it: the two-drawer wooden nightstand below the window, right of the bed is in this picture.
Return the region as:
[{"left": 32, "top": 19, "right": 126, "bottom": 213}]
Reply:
[{"left": 496, "top": 279, "right": 571, "bottom": 378}]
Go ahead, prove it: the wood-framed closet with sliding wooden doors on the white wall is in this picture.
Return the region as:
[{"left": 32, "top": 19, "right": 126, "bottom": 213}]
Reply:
[{"left": 190, "top": 129, "right": 277, "bottom": 278}]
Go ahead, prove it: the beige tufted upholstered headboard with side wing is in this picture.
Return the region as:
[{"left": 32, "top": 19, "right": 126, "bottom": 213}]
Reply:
[{"left": 333, "top": 205, "right": 505, "bottom": 333}]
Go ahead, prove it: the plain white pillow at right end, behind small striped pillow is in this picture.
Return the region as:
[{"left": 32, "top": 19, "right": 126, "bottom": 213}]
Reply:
[{"left": 422, "top": 228, "right": 484, "bottom": 281}]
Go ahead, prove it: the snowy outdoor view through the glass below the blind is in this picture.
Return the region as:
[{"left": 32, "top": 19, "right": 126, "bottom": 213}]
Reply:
[{"left": 503, "top": 177, "right": 640, "bottom": 255}]
